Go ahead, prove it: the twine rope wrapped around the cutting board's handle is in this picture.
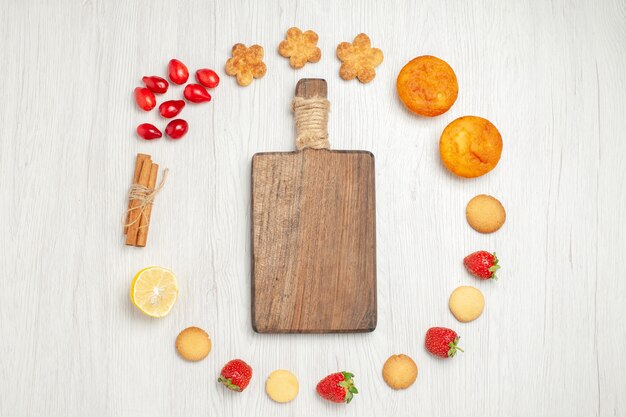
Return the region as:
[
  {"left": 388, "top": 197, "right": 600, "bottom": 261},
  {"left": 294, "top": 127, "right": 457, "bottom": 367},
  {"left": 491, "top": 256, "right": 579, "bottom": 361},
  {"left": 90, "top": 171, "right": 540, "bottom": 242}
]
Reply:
[{"left": 291, "top": 97, "right": 330, "bottom": 151}]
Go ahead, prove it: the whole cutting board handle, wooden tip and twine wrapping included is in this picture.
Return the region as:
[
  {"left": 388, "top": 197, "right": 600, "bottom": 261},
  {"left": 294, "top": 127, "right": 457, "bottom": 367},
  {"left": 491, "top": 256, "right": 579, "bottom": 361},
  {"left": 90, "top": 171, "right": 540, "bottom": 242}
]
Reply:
[{"left": 292, "top": 78, "right": 330, "bottom": 151}]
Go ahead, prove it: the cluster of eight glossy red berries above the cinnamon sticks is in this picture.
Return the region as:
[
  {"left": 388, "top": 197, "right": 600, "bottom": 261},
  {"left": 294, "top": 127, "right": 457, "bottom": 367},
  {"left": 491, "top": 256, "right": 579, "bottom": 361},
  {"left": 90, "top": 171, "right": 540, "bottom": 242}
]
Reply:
[{"left": 135, "top": 59, "right": 220, "bottom": 140}]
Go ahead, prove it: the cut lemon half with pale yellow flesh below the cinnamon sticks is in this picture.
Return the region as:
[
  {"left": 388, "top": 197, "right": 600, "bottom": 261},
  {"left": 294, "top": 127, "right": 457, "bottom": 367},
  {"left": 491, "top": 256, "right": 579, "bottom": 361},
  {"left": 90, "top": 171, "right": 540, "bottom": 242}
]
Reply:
[{"left": 130, "top": 266, "right": 178, "bottom": 317}]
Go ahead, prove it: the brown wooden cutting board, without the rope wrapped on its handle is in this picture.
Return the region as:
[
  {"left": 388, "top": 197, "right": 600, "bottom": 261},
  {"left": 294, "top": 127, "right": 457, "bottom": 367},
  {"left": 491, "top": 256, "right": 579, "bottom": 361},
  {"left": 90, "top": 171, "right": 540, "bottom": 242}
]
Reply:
[{"left": 252, "top": 79, "right": 377, "bottom": 333}]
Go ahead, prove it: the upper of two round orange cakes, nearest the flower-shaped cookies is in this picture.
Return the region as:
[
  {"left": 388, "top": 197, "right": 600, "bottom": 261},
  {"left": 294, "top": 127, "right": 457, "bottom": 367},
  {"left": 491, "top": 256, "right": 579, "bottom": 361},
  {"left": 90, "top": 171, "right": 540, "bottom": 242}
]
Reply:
[{"left": 396, "top": 55, "right": 459, "bottom": 117}]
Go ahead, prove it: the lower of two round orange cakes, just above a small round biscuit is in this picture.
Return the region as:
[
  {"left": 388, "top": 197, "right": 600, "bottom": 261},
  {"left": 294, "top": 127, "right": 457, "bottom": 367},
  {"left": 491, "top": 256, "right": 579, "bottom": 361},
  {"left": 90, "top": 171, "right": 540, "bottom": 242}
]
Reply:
[{"left": 439, "top": 116, "right": 502, "bottom": 178}]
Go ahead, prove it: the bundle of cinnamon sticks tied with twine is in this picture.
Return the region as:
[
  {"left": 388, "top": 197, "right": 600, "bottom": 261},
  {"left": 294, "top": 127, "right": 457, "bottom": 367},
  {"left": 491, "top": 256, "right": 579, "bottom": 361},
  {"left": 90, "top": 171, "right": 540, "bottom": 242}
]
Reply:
[{"left": 124, "top": 153, "right": 159, "bottom": 247}]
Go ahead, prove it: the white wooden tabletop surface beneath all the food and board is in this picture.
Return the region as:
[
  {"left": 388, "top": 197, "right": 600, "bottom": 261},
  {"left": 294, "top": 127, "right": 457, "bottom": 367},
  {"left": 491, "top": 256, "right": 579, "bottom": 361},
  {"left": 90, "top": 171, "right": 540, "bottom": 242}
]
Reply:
[{"left": 0, "top": 0, "right": 626, "bottom": 417}]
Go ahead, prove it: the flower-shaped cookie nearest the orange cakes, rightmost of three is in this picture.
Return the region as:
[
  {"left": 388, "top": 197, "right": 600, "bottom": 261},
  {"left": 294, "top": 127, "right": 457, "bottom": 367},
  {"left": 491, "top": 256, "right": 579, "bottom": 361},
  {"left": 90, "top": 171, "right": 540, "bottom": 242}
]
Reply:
[{"left": 337, "top": 33, "right": 383, "bottom": 83}]
